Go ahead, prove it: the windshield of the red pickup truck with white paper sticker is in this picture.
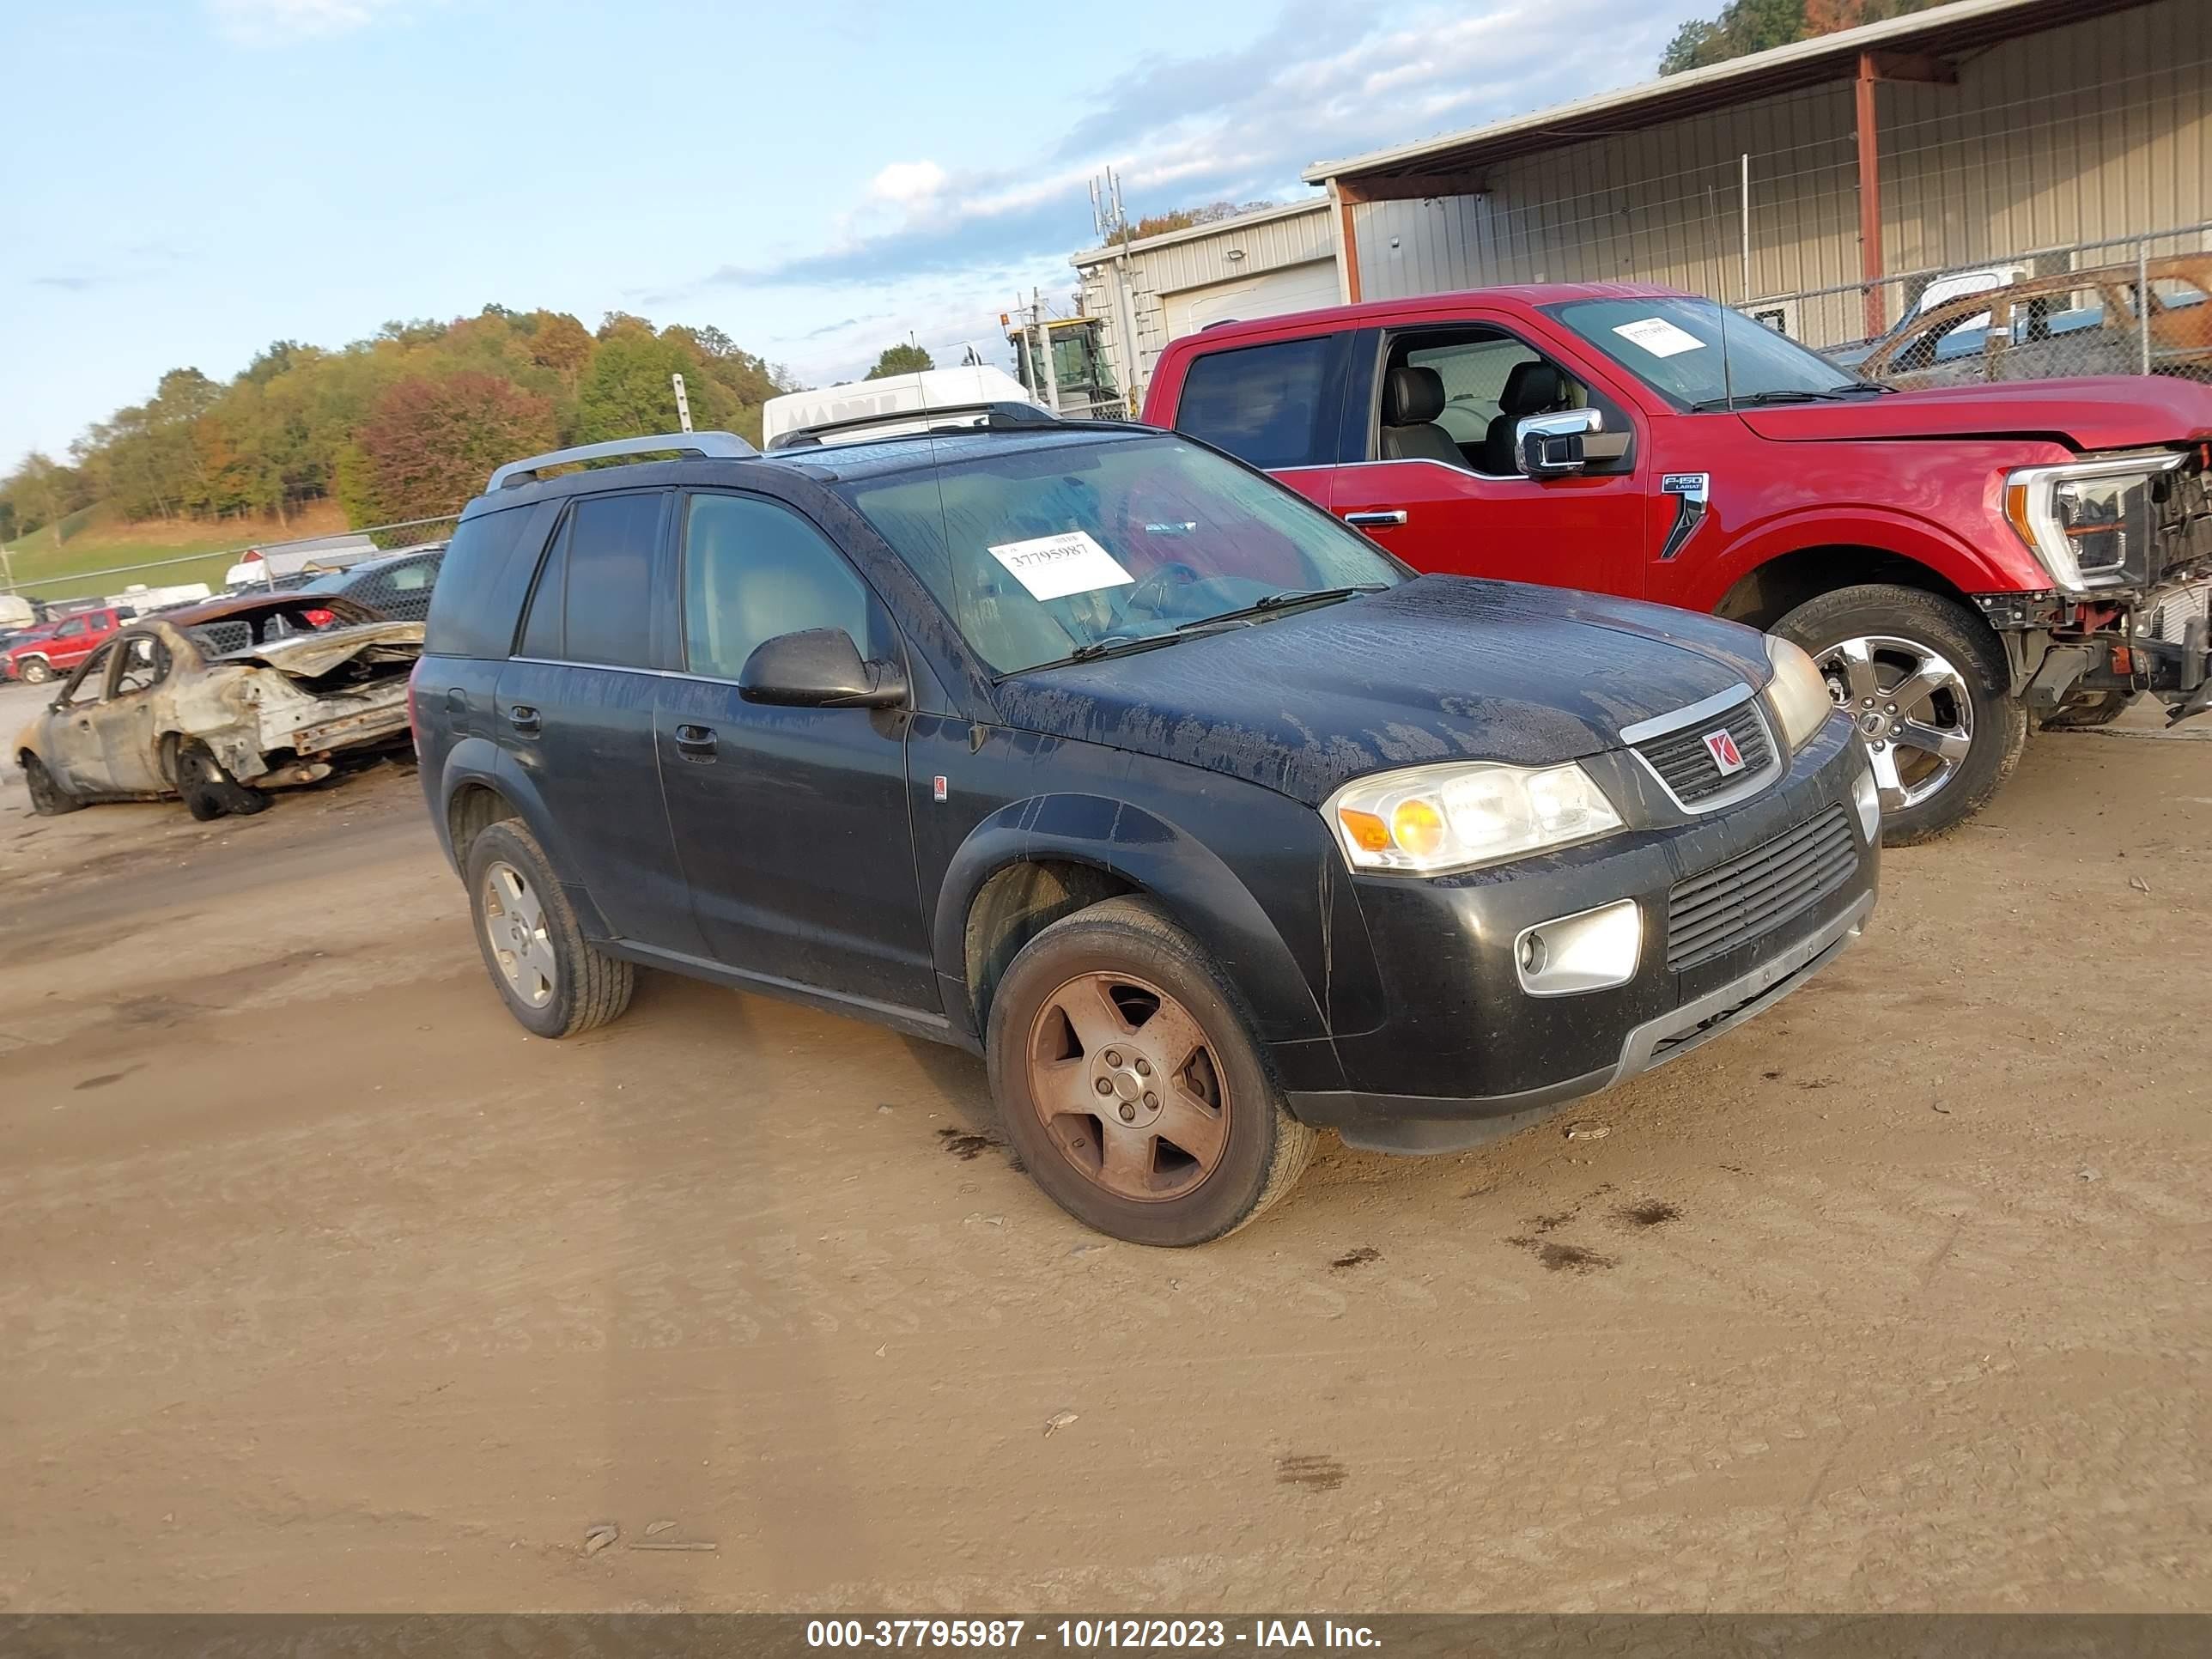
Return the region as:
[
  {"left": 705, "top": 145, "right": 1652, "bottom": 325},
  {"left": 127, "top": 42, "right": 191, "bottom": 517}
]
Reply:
[{"left": 1544, "top": 295, "right": 1887, "bottom": 410}]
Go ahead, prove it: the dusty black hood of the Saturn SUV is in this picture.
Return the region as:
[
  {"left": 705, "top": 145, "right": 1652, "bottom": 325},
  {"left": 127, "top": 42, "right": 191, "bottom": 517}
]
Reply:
[{"left": 998, "top": 575, "right": 1770, "bottom": 807}]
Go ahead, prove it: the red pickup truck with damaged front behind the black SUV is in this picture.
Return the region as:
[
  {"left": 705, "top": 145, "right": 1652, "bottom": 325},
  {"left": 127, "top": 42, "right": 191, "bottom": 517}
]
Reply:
[{"left": 1144, "top": 285, "right": 2212, "bottom": 842}]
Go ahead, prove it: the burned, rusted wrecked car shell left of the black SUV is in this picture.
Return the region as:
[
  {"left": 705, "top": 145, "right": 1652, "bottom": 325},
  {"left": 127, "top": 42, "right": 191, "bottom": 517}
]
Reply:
[{"left": 15, "top": 592, "right": 422, "bottom": 818}]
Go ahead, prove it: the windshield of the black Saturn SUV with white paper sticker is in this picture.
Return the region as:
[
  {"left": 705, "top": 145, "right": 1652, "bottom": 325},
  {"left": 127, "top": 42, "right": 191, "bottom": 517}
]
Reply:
[{"left": 841, "top": 434, "right": 1405, "bottom": 675}]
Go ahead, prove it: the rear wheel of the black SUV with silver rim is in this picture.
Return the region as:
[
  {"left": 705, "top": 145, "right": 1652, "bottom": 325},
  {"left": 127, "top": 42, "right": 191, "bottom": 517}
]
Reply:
[{"left": 467, "top": 818, "right": 637, "bottom": 1037}]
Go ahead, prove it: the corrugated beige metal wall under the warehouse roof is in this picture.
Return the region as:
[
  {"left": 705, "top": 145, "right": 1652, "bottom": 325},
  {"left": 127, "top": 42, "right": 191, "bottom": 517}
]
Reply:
[{"left": 1354, "top": 0, "right": 2212, "bottom": 338}]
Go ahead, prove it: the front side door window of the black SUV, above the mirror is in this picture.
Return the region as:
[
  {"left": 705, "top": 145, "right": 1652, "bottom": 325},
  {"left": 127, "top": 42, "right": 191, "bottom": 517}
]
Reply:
[{"left": 684, "top": 495, "right": 869, "bottom": 679}]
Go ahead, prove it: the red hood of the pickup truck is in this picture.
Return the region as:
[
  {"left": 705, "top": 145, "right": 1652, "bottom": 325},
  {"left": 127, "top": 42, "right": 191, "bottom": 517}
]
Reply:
[{"left": 1736, "top": 374, "right": 2212, "bottom": 449}]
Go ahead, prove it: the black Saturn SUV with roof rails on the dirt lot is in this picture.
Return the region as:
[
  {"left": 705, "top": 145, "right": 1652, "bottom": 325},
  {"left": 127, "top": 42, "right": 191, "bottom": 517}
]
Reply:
[{"left": 411, "top": 416, "right": 1878, "bottom": 1245}]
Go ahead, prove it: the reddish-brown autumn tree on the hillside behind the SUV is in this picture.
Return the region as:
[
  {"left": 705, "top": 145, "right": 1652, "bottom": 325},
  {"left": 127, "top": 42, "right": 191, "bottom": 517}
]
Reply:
[{"left": 347, "top": 369, "right": 557, "bottom": 525}]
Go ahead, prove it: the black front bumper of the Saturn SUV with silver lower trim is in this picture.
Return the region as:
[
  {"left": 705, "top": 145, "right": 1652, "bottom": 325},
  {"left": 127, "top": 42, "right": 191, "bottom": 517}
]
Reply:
[{"left": 1287, "top": 719, "right": 1881, "bottom": 1152}]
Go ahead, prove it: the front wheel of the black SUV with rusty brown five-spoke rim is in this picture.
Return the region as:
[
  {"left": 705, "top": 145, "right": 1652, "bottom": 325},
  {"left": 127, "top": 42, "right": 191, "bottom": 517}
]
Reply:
[{"left": 984, "top": 898, "right": 1316, "bottom": 1245}]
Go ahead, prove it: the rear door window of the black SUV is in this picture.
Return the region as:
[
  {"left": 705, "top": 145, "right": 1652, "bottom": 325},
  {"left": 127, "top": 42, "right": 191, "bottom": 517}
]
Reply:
[{"left": 522, "top": 491, "right": 661, "bottom": 668}]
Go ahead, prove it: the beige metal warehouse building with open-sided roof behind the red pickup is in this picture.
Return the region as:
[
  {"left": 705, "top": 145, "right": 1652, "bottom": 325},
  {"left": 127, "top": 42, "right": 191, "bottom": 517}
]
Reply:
[{"left": 1075, "top": 0, "right": 2212, "bottom": 387}]
